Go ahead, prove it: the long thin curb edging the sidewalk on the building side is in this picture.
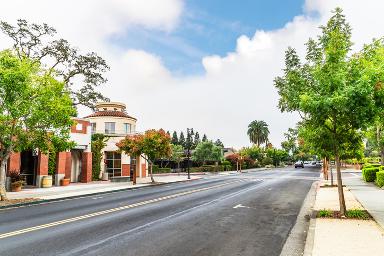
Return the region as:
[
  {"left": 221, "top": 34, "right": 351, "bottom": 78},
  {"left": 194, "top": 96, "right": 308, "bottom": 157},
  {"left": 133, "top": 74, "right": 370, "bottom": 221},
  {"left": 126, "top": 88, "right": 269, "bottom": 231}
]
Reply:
[{"left": 0, "top": 177, "right": 201, "bottom": 210}]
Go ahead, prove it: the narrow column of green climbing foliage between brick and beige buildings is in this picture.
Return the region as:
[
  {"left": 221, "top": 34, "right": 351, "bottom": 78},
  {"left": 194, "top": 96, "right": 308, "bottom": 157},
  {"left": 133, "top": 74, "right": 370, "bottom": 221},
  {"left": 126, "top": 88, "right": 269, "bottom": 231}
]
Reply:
[{"left": 91, "top": 133, "right": 109, "bottom": 180}]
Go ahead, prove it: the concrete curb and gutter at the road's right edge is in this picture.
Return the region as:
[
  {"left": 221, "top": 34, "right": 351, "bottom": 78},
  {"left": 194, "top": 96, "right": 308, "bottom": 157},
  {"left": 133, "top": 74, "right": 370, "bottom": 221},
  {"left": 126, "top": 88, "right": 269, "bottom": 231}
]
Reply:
[{"left": 280, "top": 181, "right": 319, "bottom": 256}]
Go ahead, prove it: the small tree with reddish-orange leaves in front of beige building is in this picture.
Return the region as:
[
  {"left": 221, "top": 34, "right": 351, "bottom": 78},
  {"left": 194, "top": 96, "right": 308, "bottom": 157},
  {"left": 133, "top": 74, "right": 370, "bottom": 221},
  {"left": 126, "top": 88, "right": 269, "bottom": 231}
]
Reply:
[{"left": 116, "top": 129, "right": 172, "bottom": 182}]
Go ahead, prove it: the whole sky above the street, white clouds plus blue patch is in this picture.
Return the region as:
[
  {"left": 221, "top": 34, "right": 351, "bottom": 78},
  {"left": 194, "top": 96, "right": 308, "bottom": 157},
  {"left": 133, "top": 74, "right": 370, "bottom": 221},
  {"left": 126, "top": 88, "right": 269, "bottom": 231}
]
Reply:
[{"left": 0, "top": 0, "right": 384, "bottom": 147}]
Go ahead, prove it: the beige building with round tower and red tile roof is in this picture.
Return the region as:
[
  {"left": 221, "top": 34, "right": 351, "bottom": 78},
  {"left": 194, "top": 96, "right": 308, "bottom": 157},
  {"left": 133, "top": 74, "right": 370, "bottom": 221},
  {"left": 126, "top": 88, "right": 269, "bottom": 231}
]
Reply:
[{"left": 85, "top": 102, "right": 148, "bottom": 178}]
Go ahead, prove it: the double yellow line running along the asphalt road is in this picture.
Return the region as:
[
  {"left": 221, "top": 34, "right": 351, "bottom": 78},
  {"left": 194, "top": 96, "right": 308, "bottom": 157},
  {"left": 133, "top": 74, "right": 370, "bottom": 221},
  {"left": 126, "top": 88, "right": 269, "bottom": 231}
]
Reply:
[{"left": 0, "top": 181, "right": 239, "bottom": 239}]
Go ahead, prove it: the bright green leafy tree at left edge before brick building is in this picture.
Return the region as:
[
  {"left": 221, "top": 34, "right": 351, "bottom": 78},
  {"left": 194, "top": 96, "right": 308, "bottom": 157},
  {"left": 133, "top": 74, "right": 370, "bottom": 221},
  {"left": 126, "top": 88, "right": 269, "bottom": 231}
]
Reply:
[{"left": 0, "top": 51, "right": 76, "bottom": 200}]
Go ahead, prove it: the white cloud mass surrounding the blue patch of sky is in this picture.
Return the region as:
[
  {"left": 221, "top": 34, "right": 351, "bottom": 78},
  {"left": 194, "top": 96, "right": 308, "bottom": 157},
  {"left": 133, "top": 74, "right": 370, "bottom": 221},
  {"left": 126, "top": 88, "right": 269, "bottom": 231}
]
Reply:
[{"left": 0, "top": 0, "right": 384, "bottom": 146}]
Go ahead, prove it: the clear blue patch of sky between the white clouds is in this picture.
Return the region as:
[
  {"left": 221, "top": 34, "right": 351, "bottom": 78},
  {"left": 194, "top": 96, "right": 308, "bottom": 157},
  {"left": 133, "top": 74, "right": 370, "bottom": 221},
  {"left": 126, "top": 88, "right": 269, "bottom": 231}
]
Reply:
[{"left": 113, "top": 0, "right": 304, "bottom": 76}]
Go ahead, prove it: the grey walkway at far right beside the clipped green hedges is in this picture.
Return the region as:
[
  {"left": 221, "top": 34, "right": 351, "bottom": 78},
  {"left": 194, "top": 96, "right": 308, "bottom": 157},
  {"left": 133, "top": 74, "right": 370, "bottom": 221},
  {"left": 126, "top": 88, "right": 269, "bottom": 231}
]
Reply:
[{"left": 343, "top": 174, "right": 384, "bottom": 229}]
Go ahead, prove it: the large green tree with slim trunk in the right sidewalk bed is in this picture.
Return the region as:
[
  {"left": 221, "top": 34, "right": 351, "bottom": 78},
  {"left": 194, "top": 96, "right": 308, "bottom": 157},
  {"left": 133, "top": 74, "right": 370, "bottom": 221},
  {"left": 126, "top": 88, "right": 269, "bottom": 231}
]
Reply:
[{"left": 275, "top": 8, "right": 384, "bottom": 215}]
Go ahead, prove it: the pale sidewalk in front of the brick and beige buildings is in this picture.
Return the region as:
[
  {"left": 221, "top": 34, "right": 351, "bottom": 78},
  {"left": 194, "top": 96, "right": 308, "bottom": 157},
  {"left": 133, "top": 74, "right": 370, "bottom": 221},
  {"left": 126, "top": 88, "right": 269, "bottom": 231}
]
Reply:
[{"left": 7, "top": 175, "right": 200, "bottom": 200}]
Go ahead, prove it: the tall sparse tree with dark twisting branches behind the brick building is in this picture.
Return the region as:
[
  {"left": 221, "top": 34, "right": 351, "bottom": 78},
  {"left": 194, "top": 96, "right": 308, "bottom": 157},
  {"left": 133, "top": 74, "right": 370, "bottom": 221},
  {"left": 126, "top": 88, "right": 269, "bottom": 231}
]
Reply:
[{"left": 0, "top": 19, "right": 109, "bottom": 108}]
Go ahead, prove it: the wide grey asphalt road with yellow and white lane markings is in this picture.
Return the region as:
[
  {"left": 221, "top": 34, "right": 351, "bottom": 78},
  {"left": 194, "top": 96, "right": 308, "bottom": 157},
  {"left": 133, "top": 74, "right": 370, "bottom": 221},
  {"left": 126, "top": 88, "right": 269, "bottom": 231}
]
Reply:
[{"left": 0, "top": 168, "right": 319, "bottom": 256}]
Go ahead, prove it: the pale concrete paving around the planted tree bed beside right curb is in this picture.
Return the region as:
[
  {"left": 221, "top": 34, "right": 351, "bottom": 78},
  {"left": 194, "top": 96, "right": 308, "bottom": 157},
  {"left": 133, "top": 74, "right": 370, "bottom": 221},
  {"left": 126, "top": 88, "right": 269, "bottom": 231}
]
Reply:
[{"left": 304, "top": 179, "right": 384, "bottom": 256}]
